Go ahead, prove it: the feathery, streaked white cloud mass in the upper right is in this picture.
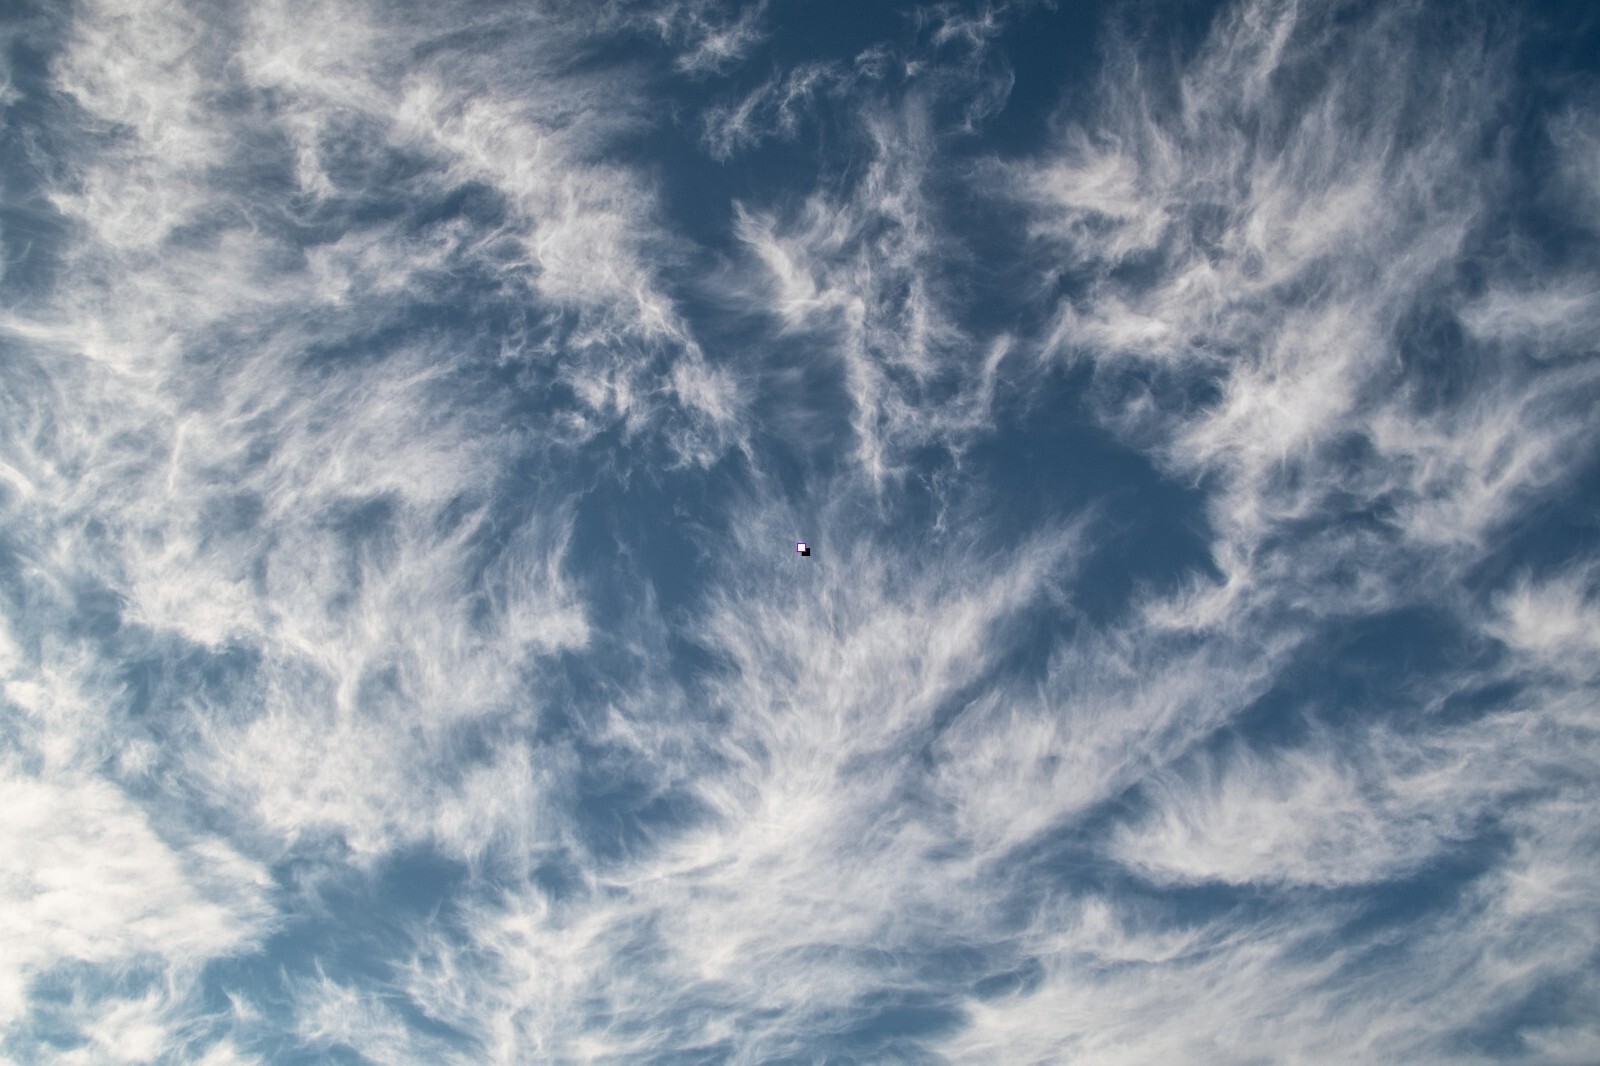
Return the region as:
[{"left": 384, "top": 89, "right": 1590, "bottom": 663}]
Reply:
[{"left": 1011, "top": 3, "right": 1592, "bottom": 563}]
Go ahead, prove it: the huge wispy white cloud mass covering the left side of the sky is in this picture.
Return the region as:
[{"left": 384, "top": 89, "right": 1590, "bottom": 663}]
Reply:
[{"left": 0, "top": 2, "right": 741, "bottom": 1061}]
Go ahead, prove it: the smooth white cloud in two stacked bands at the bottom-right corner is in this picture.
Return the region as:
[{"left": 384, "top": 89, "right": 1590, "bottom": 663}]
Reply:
[{"left": 944, "top": 672, "right": 1597, "bottom": 1061}]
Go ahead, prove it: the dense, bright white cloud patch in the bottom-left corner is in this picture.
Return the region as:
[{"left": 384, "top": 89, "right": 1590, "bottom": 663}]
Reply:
[{"left": 0, "top": 759, "right": 274, "bottom": 1061}]
